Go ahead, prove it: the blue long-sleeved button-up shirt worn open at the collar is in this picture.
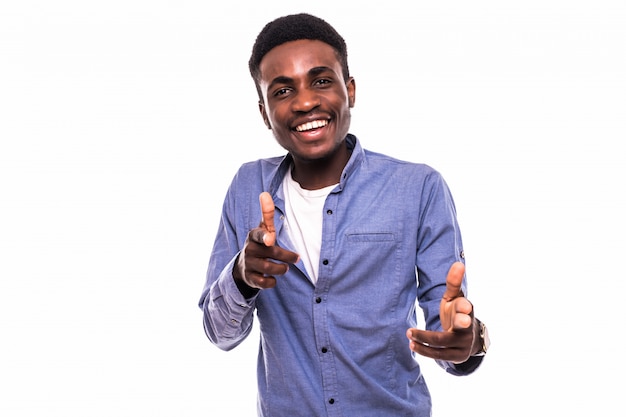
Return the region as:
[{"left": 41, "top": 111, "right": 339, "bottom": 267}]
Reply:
[{"left": 199, "top": 135, "right": 480, "bottom": 417}]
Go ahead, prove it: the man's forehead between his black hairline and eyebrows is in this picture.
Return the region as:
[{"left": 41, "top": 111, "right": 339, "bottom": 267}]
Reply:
[{"left": 259, "top": 39, "right": 341, "bottom": 82}]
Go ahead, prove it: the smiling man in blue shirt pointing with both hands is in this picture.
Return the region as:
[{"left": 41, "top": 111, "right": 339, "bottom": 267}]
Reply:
[{"left": 199, "top": 14, "right": 488, "bottom": 417}]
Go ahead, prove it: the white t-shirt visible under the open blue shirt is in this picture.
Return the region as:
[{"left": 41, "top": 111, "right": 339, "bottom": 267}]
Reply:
[{"left": 283, "top": 170, "right": 337, "bottom": 284}]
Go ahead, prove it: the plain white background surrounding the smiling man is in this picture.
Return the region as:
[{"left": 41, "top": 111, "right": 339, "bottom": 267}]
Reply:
[{"left": 0, "top": 0, "right": 626, "bottom": 417}]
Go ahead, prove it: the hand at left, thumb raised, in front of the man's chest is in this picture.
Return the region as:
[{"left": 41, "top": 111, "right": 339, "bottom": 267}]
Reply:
[{"left": 233, "top": 192, "right": 300, "bottom": 290}]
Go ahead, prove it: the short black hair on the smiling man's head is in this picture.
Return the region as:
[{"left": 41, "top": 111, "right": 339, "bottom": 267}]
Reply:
[{"left": 248, "top": 13, "right": 350, "bottom": 98}]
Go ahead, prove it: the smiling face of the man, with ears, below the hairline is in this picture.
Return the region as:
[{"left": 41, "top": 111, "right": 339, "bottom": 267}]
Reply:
[{"left": 259, "top": 40, "right": 355, "bottom": 161}]
